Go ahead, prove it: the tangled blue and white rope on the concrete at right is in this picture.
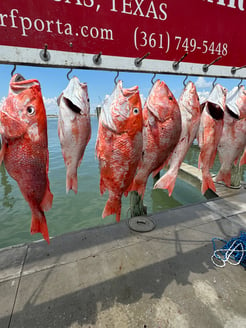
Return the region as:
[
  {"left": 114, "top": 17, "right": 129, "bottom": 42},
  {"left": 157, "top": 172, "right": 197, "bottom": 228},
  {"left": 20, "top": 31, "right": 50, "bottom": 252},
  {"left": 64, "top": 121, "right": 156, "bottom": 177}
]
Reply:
[{"left": 211, "top": 231, "right": 246, "bottom": 268}]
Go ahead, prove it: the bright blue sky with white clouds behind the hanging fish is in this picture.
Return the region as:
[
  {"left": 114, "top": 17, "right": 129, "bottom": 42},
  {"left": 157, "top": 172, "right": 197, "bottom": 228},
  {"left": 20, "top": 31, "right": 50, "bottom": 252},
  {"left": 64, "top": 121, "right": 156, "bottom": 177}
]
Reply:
[{"left": 0, "top": 64, "right": 240, "bottom": 114}]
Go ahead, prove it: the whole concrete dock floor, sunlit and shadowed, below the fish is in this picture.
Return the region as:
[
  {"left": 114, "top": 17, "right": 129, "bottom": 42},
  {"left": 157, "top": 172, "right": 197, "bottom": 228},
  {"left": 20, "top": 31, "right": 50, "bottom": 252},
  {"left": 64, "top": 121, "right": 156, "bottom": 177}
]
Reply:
[{"left": 0, "top": 188, "right": 246, "bottom": 328}]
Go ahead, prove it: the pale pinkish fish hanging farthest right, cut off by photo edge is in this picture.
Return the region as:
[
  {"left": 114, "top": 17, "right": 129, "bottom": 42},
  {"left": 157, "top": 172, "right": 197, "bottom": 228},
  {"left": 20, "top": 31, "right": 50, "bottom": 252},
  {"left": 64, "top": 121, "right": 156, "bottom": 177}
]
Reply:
[{"left": 216, "top": 86, "right": 246, "bottom": 186}]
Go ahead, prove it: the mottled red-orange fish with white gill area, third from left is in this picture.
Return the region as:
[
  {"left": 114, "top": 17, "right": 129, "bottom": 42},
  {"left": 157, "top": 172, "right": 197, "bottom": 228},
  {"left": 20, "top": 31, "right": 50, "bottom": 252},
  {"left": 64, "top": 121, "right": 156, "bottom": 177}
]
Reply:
[{"left": 96, "top": 80, "right": 143, "bottom": 221}]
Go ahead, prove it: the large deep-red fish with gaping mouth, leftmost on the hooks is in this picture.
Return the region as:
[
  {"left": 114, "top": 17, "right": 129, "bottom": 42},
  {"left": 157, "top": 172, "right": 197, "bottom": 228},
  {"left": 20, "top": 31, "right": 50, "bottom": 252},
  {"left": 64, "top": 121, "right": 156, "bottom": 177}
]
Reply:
[{"left": 0, "top": 74, "right": 53, "bottom": 243}]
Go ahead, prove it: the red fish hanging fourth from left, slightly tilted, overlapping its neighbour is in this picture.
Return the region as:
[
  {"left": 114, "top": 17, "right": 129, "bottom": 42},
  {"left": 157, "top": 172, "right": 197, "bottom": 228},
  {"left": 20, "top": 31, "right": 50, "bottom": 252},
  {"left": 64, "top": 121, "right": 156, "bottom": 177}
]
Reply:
[{"left": 132, "top": 80, "right": 181, "bottom": 198}]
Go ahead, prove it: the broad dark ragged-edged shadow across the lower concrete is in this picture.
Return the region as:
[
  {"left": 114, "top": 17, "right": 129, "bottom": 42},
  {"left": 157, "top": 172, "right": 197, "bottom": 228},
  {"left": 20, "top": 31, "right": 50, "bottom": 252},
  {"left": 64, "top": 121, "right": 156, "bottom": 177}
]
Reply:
[{"left": 0, "top": 239, "right": 216, "bottom": 328}]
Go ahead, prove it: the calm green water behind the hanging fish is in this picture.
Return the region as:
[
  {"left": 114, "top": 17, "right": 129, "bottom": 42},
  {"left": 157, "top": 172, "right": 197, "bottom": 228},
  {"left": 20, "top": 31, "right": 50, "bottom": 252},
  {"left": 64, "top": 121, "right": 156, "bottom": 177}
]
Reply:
[{"left": 0, "top": 117, "right": 242, "bottom": 248}]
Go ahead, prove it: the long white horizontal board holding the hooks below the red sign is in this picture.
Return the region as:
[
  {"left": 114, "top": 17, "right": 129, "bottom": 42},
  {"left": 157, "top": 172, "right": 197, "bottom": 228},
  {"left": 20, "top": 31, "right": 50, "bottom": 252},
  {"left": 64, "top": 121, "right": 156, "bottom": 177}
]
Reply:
[{"left": 0, "top": 46, "right": 246, "bottom": 79}]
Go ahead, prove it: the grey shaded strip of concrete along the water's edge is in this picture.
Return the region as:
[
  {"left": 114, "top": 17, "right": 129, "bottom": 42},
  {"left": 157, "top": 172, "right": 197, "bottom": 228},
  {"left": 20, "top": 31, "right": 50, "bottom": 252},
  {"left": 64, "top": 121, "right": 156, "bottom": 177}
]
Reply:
[{"left": 0, "top": 191, "right": 246, "bottom": 268}]
